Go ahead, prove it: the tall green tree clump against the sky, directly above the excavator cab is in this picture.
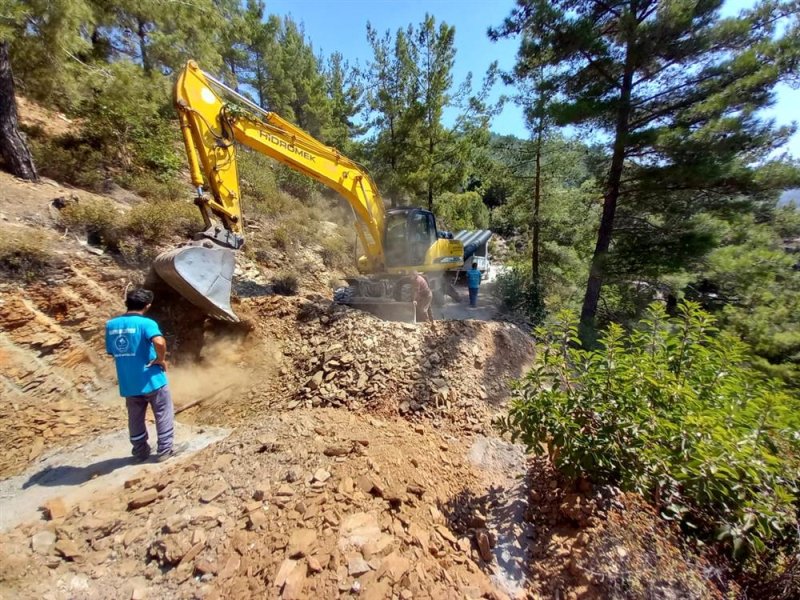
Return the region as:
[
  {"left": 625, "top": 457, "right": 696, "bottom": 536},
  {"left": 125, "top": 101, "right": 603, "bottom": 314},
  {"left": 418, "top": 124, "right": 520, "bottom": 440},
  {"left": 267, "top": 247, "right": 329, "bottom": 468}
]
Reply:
[{"left": 367, "top": 15, "right": 497, "bottom": 209}]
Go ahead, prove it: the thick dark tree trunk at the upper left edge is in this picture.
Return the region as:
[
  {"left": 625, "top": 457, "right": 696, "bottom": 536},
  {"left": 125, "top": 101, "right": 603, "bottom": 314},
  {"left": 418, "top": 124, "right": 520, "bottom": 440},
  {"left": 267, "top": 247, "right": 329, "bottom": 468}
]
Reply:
[{"left": 0, "top": 42, "right": 39, "bottom": 181}]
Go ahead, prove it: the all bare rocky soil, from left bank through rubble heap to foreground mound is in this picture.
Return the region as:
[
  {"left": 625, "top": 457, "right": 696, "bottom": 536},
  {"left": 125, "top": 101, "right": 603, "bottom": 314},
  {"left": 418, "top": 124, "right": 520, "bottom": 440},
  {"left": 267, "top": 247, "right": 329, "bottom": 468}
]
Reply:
[{"left": 0, "top": 175, "right": 717, "bottom": 600}]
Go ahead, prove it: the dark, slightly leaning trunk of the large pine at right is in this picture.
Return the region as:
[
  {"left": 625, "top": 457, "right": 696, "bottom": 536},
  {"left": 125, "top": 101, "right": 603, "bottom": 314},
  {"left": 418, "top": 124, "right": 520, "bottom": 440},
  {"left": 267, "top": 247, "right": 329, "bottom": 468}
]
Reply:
[{"left": 580, "top": 42, "right": 635, "bottom": 347}]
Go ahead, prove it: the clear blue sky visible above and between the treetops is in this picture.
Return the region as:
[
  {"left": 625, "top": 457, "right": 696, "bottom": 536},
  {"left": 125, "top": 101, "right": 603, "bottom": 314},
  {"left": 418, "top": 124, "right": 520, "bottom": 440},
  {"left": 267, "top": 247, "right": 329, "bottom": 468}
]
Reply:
[{"left": 266, "top": 0, "right": 800, "bottom": 158}]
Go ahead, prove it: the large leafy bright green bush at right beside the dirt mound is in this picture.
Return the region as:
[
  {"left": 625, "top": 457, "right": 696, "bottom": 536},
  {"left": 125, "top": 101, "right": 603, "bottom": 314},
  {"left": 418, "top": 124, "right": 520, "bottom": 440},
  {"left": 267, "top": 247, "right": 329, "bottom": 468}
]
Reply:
[{"left": 499, "top": 302, "right": 800, "bottom": 557}]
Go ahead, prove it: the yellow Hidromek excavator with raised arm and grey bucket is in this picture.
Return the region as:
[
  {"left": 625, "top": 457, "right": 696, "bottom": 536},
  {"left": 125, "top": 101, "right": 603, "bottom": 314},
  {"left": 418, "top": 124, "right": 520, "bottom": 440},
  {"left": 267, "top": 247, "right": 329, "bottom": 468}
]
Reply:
[{"left": 153, "top": 61, "right": 464, "bottom": 321}]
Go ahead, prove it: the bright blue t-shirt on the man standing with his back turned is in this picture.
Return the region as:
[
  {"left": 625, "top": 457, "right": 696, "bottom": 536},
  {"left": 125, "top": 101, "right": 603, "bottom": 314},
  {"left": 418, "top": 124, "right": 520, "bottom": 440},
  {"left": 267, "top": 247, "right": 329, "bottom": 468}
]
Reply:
[{"left": 106, "top": 315, "right": 167, "bottom": 397}]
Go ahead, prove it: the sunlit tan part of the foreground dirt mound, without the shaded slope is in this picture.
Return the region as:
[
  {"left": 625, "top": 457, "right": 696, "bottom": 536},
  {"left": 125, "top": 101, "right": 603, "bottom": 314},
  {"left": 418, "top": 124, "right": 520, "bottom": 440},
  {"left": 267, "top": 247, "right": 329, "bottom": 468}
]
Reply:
[{"left": 0, "top": 409, "right": 502, "bottom": 599}]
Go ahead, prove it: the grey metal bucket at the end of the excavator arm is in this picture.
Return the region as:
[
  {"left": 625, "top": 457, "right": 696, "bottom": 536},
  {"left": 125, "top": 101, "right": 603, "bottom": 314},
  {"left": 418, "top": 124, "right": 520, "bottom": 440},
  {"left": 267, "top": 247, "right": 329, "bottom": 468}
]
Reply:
[{"left": 153, "top": 246, "right": 239, "bottom": 322}]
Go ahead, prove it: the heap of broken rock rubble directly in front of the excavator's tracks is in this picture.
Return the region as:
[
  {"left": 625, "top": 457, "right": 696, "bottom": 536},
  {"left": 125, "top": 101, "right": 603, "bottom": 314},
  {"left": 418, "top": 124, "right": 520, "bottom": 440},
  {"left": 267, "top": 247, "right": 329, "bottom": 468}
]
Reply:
[{"left": 176, "top": 295, "right": 533, "bottom": 432}]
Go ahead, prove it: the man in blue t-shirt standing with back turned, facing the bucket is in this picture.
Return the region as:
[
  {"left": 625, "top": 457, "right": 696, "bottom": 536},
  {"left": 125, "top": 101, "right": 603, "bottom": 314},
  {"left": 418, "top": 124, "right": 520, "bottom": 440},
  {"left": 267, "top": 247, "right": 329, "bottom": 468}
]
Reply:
[{"left": 106, "top": 289, "right": 178, "bottom": 462}]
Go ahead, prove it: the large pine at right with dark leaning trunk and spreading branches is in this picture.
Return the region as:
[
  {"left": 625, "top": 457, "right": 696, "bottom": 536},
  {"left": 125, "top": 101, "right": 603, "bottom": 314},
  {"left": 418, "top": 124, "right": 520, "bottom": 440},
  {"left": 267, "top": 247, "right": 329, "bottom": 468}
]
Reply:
[{"left": 490, "top": 0, "right": 800, "bottom": 342}]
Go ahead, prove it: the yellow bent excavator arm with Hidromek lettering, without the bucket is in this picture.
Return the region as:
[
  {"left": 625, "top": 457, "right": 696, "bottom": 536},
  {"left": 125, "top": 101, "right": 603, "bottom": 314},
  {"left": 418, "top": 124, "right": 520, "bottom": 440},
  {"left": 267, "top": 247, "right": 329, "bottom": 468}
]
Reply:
[{"left": 174, "top": 61, "right": 385, "bottom": 273}]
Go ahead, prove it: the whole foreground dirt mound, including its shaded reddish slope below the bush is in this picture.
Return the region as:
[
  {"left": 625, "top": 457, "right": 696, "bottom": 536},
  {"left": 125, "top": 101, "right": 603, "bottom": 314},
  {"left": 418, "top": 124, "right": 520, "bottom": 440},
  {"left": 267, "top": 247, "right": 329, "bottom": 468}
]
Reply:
[{"left": 0, "top": 408, "right": 722, "bottom": 600}]
